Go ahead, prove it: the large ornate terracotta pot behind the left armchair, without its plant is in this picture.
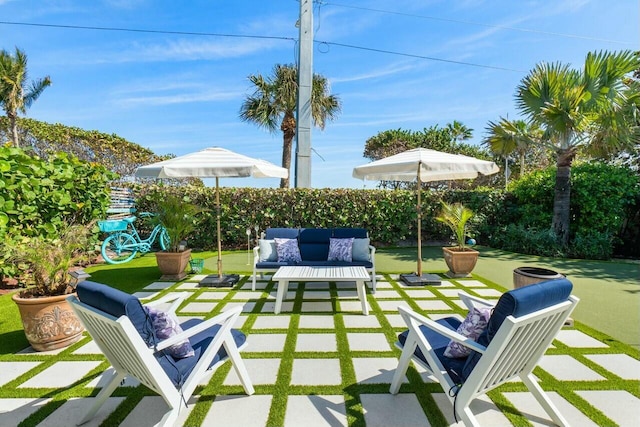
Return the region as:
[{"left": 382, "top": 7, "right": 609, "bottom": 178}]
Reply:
[{"left": 12, "top": 293, "right": 84, "bottom": 351}]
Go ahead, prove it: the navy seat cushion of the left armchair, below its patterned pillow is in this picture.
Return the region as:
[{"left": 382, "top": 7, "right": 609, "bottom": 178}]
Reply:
[{"left": 161, "top": 319, "right": 247, "bottom": 387}]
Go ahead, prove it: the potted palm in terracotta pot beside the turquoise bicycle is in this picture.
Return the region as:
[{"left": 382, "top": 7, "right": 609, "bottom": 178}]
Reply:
[{"left": 150, "top": 193, "right": 203, "bottom": 280}]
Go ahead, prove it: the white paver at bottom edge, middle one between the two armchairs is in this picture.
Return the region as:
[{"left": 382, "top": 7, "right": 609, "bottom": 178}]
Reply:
[{"left": 284, "top": 395, "right": 348, "bottom": 427}]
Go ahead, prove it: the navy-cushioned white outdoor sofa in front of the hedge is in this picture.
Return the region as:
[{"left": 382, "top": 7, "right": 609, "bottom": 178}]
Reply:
[{"left": 251, "top": 228, "right": 376, "bottom": 293}]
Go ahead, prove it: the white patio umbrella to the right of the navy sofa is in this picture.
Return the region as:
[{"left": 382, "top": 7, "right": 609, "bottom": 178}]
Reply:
[{"left": 353, "top": 148, "right": 500, "bottom": 284}]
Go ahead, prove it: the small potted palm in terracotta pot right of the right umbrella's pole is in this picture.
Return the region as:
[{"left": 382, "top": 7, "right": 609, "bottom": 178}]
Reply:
[{"left": 436, "top": 202, "right": 480, "bottom": 277}]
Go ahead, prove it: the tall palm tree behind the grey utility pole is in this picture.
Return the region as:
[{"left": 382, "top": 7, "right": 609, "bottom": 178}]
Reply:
[{"left": 240, "top": 64, "right": 340, "bottom": 188}]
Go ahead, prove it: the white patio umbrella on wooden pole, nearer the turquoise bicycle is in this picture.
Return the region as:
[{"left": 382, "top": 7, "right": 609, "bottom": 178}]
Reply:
[{"left": 135, "top": 147, "right": 289, "bottom": 285}]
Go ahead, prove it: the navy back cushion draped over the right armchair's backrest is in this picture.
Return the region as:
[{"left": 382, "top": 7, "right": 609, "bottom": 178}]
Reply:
[{"left": 462, "top": 279, "right": 573, "bottom": 379}]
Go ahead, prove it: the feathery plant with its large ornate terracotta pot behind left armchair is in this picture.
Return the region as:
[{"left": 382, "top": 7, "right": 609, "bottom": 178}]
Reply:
[{"left": 3, "top": 223, "right": 93, "bottom": 351}]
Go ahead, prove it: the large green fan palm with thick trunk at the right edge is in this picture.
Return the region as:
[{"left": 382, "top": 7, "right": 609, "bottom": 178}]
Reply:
[{"left": 516, "top": 50, "right": 640, "bottom": 246}]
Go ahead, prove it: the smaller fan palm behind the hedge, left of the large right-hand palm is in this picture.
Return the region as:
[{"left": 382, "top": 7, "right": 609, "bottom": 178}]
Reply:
[{"left": 483, "top": 117, "right": 542, "bottom": 177}]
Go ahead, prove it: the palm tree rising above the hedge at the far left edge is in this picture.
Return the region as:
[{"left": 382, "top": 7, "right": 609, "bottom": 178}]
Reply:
[{"left": 0, "top": 48, "right": 51, "bottom": 147}]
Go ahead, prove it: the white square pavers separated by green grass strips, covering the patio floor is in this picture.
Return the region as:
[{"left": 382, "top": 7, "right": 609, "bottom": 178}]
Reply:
[{"left": 0, "top": 275, "right": 640, "bottom": 427}]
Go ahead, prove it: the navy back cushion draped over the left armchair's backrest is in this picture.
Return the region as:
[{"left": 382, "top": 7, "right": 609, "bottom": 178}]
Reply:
[{"left": 76, "top": 280, "right": 156, "bottom": 346}]
